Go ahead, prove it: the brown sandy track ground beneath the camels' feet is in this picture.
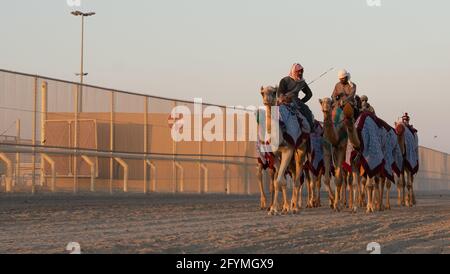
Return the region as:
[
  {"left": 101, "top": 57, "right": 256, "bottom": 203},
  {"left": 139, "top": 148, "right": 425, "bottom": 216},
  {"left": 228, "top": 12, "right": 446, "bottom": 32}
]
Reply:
[{"left": 0, "top": 193, "right": 450, "bottom": 254}]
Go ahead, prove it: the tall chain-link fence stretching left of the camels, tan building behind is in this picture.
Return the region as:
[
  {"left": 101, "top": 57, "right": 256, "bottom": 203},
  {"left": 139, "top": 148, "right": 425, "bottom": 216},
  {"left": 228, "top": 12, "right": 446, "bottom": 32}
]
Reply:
[{"left": 0, "top": 70, "right": 258, "bottom": 194}]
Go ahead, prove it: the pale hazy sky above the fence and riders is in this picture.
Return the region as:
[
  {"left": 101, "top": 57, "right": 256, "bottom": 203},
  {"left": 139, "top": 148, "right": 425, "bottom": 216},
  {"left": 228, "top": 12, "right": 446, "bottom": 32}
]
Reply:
[{"left": 0, "top": 0, "right": 450, "bottom": 153}]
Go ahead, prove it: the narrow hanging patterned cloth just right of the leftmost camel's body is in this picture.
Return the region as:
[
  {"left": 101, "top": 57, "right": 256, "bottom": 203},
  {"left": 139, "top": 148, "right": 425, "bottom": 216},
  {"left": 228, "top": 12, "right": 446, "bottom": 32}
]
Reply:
[{"left": 307, "top": 121, "right": 324, "bottom": 176}]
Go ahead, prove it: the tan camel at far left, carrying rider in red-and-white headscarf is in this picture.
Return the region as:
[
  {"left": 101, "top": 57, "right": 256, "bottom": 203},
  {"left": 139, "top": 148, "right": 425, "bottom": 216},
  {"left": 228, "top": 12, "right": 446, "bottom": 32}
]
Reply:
[{"left": 261, "top": 86, "right": 307, "bottom": 215}]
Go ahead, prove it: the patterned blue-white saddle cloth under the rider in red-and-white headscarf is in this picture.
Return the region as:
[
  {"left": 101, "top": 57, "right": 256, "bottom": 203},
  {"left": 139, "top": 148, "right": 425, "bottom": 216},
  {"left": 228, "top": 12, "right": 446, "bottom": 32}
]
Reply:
[{"left": 278, "top": 103, "right": 311, "bottom": 147}]
